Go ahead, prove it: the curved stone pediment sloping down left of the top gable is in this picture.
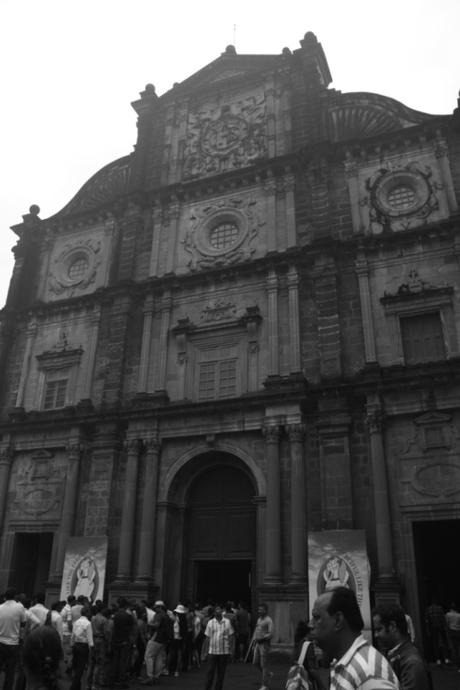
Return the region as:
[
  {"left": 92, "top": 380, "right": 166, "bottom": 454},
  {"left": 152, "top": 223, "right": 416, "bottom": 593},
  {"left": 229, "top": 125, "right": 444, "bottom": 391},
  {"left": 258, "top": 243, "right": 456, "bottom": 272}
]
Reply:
[{"left": 56, "top": 156, "right": 131, "bottom": 217}]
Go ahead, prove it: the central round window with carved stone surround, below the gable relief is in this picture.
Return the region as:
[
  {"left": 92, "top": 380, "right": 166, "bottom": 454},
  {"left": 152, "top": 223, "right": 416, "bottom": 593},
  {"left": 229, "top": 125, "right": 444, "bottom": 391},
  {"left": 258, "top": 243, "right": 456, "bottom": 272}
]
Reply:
[{"left": 182, "top": 197, "right": 263, "bottom": 271}]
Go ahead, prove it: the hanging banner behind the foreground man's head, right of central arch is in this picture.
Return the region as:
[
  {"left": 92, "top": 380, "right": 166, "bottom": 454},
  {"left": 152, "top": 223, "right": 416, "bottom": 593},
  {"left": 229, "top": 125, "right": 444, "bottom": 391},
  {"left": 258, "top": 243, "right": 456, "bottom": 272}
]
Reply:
[{"left": 308, "top": 529, "right": 371, "bottom": 630}]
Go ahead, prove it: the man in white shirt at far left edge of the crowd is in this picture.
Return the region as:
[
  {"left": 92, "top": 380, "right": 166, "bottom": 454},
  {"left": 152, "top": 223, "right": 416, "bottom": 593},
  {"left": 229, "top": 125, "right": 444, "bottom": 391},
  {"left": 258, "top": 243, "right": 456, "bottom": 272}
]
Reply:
[{"left": 0, "top": 589, "right": 26, "bottom": 690}]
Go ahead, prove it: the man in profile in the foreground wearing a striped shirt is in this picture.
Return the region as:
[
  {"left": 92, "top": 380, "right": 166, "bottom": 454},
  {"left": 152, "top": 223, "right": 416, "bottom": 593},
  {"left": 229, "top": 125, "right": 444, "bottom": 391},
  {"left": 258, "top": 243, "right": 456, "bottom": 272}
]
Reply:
[{"left": 311, "top": 587, "right": 400, "bottom": 690}]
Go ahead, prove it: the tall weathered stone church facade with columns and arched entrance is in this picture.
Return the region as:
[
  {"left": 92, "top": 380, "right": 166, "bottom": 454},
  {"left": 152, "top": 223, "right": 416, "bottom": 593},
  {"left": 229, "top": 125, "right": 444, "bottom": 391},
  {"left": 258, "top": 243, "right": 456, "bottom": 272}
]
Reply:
[{"left": 0, "top": 33, "right": 460, "bottom": 646}]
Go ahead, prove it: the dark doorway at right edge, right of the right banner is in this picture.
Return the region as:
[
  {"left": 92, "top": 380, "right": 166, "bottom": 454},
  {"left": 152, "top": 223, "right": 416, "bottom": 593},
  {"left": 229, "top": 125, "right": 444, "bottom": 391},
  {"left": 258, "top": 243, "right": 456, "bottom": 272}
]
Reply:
[{"left": 413, "top": 520, "right": 460, "bottom": 654}]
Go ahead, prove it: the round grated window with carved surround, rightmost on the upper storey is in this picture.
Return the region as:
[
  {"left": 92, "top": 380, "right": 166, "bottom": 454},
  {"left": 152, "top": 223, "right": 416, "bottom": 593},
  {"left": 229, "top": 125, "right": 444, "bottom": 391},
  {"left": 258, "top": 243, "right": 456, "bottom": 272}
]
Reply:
[{"left": 361, "top": 163, "right": 441, "bottom": 230}]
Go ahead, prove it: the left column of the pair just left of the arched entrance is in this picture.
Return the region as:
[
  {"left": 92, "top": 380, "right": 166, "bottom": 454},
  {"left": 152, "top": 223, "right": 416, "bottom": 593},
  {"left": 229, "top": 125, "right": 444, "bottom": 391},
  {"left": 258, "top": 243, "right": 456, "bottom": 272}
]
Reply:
[{"left": 116, "top": 438, "right": 139, "bottom": 582}]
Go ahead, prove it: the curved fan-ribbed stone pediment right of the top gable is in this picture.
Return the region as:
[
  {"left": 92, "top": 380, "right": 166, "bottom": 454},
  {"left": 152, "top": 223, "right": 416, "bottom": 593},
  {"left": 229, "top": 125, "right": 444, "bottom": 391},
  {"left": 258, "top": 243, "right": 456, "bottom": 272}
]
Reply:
[{"left": 327, "top": 92, "right": 438, "bottom": 141}]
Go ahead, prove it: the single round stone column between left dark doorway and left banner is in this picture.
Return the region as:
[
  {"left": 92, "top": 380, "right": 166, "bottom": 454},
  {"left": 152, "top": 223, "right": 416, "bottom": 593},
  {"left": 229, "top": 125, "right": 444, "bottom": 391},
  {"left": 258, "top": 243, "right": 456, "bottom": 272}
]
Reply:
[{"left": 54, "top": 440, "right": 83, "bottom": 581}]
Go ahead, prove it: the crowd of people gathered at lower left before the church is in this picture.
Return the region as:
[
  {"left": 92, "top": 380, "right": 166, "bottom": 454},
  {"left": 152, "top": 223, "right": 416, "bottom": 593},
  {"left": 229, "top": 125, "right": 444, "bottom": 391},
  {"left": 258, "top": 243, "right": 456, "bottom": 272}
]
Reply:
[{"left": 0, "top": 589, "right": 262, "bottom": 690}]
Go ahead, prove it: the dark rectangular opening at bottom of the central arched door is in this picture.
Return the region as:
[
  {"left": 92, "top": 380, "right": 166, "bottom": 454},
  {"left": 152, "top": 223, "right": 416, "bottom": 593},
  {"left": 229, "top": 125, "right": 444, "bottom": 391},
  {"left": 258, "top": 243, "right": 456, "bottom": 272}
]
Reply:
[{"left": 195, "top": 561, "right": 251, "bottom": 605}]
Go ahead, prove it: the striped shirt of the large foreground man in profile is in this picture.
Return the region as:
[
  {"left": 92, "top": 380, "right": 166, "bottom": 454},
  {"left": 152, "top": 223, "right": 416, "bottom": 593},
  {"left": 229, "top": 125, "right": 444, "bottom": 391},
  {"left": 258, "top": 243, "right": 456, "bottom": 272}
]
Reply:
[{"left": 330, "top": 635, "right": 399, "bottom": 690}]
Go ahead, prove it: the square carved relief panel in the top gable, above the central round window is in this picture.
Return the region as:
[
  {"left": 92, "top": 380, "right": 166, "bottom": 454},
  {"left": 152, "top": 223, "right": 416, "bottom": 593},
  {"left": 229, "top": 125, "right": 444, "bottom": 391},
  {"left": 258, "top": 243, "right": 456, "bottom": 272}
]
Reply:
[{"left": 183, "top": 93, "right": 267, "bottom": 179}]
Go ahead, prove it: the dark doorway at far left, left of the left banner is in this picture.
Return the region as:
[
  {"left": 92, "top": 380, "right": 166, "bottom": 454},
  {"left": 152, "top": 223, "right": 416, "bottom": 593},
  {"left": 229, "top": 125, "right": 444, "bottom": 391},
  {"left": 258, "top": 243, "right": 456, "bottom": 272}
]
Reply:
[{"left": 9, "top": 532, "right": 54, "bottom": 596}]
